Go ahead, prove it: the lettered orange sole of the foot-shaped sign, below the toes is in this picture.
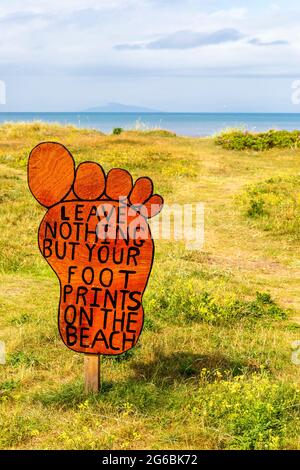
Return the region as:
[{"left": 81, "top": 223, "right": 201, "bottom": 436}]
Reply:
[{"left": 39, "top": 201, "right": 153, "bottom": 355}]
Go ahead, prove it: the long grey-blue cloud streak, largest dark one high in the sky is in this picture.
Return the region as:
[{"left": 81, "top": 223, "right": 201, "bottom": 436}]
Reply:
[{"left": 115, "top": 28, "right": 244, "bottom": 50}]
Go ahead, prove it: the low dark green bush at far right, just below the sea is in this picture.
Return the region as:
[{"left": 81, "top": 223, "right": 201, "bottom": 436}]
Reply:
[{"left": 215, "top": 130, "right": 300, "bottom": 151}]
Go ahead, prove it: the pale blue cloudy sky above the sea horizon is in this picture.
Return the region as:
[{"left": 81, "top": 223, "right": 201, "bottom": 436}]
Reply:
[{"left": 0, "top": 0, "right": 300, "bottom": 112}]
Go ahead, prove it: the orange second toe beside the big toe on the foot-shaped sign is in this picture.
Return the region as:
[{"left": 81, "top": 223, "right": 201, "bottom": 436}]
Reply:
[{"left": 74, "top": 162, "right": 105, "bottom": 201}]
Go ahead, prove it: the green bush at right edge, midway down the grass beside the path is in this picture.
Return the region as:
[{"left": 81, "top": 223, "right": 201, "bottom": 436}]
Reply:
[{"left": 236, "top": 175, "right": 300, "bottom": 239}]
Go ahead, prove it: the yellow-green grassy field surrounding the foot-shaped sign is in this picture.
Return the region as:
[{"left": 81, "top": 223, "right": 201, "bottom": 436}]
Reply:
[{"left": 0, "top": 123, "right": 300, "bottom": 449}]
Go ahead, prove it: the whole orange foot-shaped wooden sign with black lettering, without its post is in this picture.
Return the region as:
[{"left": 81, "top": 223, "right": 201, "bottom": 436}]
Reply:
[{"left": 28, "top": 142, "right": 163, "bottom": 355}]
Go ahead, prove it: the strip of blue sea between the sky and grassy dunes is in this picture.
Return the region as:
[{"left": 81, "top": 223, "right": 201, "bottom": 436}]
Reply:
[{"left": 0, "top": 112, "right": 300, "bottom": 136}]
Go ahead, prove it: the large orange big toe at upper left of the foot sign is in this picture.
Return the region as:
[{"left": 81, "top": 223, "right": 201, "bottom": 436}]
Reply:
[{"left": 28, "top": 142, "right": 75, "bottom": 207}]
